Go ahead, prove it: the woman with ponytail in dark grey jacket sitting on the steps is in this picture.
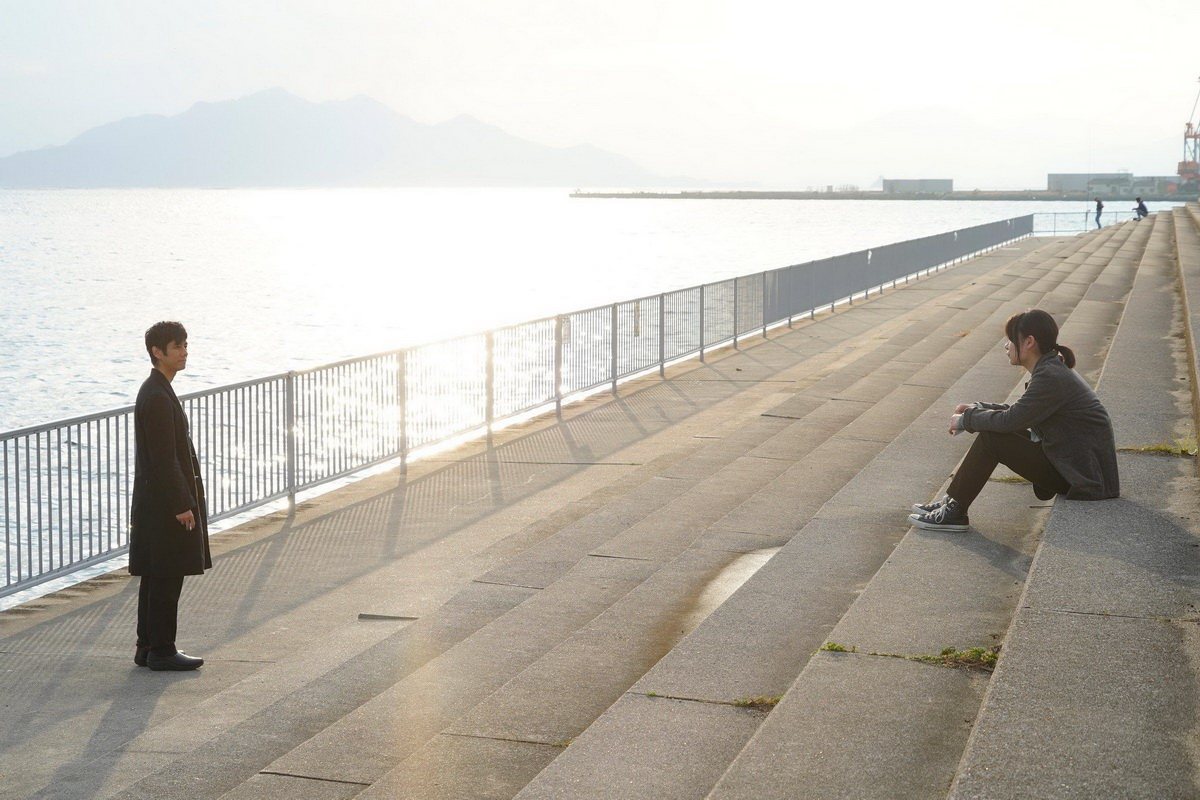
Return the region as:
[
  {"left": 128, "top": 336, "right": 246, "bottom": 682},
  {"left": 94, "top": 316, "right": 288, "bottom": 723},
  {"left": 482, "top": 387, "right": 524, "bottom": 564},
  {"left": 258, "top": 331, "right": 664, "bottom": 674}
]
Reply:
[{"left": 910, "top": 309, "right": 1121, "bottom": 530}]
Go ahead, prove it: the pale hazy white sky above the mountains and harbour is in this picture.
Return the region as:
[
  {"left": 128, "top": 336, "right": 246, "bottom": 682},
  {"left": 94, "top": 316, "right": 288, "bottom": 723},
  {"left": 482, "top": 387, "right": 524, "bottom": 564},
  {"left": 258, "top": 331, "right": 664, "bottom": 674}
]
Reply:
[{"left": 0, "top": 0, "right": 1200, "bottom": 188}]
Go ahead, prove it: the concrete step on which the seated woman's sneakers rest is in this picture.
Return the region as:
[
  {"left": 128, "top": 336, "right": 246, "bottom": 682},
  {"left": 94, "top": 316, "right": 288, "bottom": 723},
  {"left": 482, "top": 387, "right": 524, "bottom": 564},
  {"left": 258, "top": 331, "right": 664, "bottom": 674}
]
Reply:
[{"left": 712, "top": 219, "right": 1145, "bottom": 798}]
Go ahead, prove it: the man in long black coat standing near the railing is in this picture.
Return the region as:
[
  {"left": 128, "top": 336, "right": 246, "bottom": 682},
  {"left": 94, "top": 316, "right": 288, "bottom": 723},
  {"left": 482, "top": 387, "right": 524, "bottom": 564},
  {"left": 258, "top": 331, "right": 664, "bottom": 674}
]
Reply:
[{"left": 130, "top": 323, "right": 212, "bottom": 669}]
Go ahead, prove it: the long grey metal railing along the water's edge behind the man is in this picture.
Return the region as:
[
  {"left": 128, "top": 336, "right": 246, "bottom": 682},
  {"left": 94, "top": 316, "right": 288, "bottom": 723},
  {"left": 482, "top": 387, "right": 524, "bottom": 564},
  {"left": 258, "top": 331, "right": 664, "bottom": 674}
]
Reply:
[{"left": 0, "top": 216, "right": 1033, "bottom": 596}]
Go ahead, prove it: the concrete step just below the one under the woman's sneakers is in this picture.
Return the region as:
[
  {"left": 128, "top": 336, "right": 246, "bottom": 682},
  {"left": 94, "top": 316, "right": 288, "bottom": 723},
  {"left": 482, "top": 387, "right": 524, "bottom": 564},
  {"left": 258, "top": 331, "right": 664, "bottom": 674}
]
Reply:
[{"left": 508, "top": 225, "right": 1142, "bottom": 798}]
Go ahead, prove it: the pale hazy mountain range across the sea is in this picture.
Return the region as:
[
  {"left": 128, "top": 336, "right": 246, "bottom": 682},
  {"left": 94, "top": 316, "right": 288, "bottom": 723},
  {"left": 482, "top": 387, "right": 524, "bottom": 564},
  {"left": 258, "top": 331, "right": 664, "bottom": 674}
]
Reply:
[{"left": 0, "top": 89, "right": 686, "bottom": 188}]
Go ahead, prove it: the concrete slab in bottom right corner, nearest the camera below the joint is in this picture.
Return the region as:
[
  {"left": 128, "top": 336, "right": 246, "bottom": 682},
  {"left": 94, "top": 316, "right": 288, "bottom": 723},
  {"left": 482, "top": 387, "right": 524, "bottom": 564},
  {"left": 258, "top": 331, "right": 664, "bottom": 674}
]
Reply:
[{"left": 952, "top": 609, "right": 1200, "bottom": 798}]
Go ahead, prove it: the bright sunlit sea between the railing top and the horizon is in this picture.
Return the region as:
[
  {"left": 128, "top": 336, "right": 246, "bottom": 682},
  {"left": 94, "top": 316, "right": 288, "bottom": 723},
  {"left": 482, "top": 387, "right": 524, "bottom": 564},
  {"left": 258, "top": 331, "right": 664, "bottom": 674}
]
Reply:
[{"left": 0, "top": 188, "right": 1171, "bottom": 431}]
